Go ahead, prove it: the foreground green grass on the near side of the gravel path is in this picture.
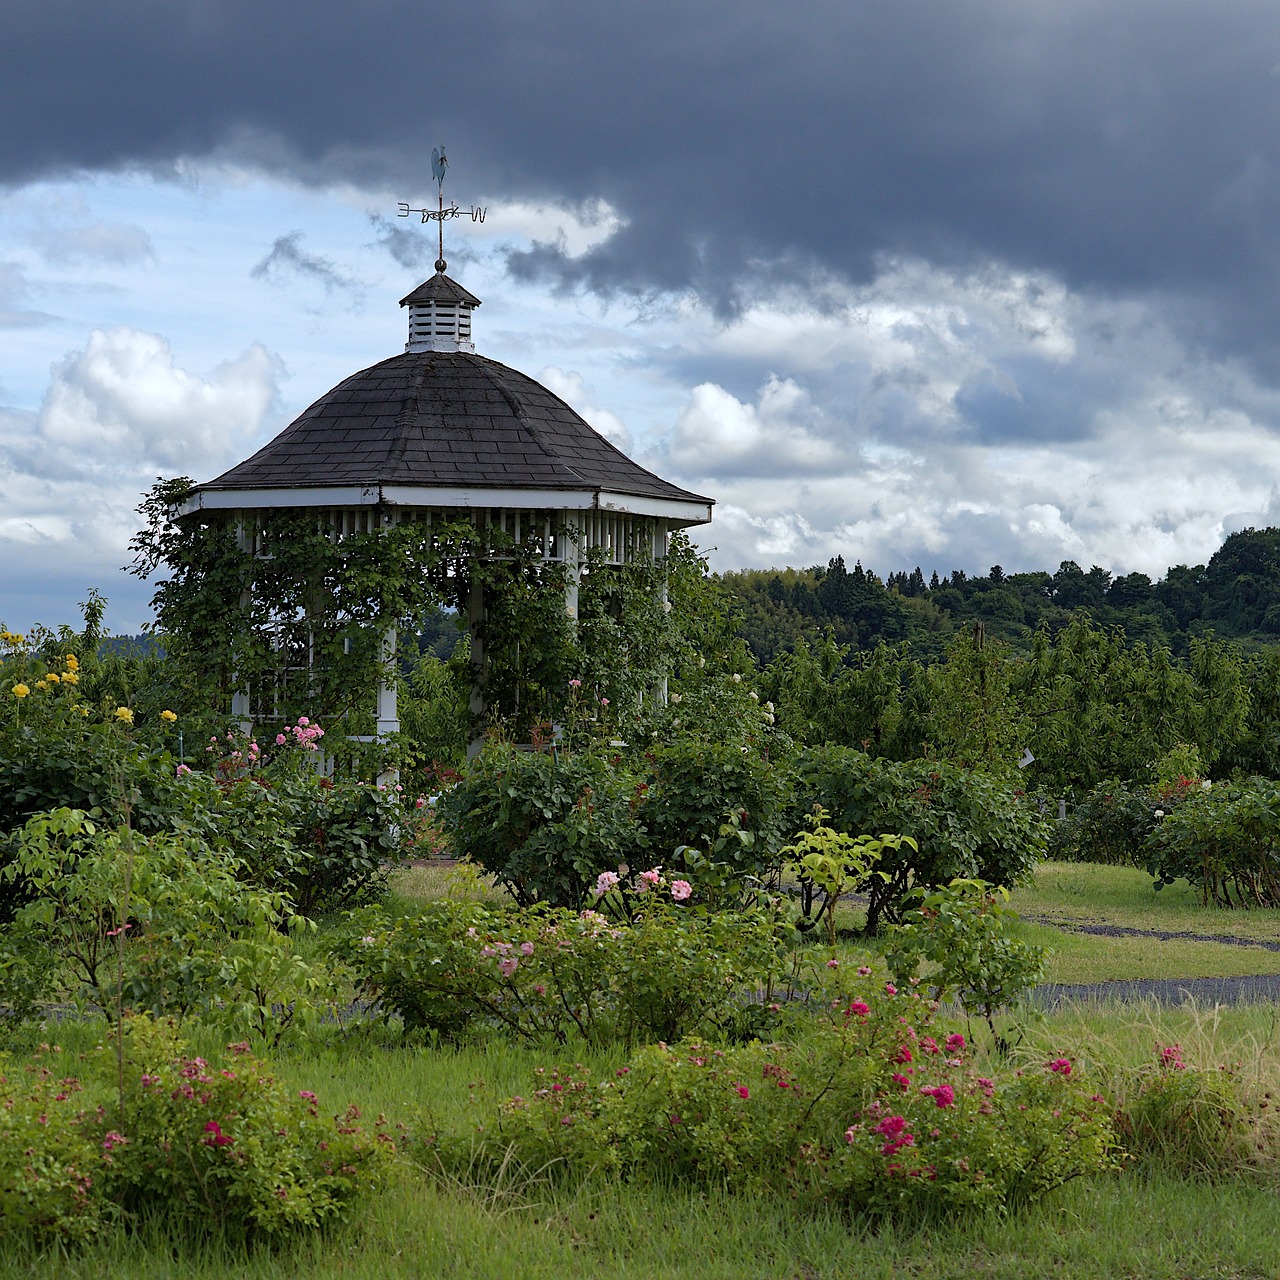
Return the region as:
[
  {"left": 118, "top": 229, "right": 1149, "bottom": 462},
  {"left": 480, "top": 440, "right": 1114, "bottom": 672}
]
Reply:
[{"left": 0, "top": 1007, "right": 1280, "bottom": 1280}]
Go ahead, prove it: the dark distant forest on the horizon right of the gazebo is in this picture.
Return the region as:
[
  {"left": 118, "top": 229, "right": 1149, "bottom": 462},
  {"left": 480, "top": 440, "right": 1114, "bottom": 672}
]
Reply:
[{"left": 717, "top": 529, "right": 1280, "bottom": 666}]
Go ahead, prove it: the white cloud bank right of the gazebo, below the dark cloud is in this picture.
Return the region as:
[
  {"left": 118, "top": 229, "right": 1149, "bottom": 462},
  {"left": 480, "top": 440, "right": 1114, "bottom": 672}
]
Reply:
[{"left": 675, "top": 265, "right": 1280, "bottom": 576}]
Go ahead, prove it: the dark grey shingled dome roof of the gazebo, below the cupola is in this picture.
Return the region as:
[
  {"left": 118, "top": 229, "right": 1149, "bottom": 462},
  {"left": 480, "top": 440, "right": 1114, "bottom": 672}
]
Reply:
[{"left": 196, "top": 350, "right": 713, "bottom": 522}]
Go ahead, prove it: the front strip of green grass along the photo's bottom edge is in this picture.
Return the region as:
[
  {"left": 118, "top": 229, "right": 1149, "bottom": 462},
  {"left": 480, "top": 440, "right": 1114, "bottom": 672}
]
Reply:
[{"left": 10, "top": 1176, "right": 1280, "bottom": 1280}]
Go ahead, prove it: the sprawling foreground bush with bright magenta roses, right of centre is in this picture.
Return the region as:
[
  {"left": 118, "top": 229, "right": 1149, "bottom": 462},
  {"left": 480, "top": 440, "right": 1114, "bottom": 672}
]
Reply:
[{"left": 435, "top": 972, "right": 1111, "bottom": 1212}]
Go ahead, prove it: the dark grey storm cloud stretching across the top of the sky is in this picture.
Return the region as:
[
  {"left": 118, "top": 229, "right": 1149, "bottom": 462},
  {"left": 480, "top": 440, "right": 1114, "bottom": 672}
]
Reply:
[{"left": 0, "top": 0, "right": 1280, "bottom": 360}]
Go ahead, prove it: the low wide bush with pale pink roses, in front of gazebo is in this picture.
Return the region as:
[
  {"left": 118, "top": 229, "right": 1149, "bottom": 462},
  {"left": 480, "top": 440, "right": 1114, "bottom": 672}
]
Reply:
[{"left": 340, "top": 876, "right": 778, "bottom": 1044}]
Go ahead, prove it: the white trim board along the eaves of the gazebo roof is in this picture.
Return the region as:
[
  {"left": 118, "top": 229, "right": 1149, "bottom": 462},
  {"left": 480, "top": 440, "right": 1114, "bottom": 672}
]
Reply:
[{"left": 185, "top": 485, "right": 712, "bottom": 525}]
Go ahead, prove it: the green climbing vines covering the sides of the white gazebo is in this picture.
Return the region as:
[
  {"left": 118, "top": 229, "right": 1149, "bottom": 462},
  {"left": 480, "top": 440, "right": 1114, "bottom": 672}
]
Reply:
[{"left": 131, "top": 476, "right": 696, "bottom": 742}]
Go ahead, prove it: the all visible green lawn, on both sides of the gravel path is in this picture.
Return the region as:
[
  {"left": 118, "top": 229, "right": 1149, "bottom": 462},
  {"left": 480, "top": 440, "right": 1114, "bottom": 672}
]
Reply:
[{"left": 12, "top": 864, "right": 1280, "bottom": 1280}]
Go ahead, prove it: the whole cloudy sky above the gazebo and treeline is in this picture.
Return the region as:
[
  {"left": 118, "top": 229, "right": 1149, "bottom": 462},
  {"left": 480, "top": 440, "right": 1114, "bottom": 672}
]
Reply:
[{"left": 0, "top": 0, "right": 1280, "bottom": 631}]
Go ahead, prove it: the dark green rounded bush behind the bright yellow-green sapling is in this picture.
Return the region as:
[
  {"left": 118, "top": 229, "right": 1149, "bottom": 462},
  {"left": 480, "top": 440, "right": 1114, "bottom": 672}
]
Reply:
[{"left": 795, "top": 746, "right": 1044, "bottom": 933}]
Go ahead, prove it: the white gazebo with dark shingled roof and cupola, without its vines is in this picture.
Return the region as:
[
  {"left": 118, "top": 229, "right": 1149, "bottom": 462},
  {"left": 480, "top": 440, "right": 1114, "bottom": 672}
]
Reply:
[{"left": 177, "top": 259, "right": 713, "bottom": 737}]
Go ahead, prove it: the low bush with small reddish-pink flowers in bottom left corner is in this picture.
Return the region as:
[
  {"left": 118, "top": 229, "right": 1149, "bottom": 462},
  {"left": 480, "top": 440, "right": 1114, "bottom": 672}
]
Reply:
[{"left": 0, "top": 1018, "right": 394, "bottom": 1240}]
